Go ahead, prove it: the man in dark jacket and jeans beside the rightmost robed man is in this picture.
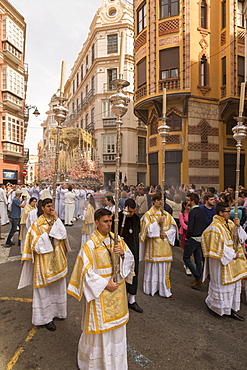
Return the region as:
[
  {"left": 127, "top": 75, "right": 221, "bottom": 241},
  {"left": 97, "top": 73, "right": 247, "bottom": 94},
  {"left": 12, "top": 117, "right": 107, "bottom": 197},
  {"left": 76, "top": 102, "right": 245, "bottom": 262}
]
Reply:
[{"left": 183, "top": 193, "right": 206, "bottom": 289}]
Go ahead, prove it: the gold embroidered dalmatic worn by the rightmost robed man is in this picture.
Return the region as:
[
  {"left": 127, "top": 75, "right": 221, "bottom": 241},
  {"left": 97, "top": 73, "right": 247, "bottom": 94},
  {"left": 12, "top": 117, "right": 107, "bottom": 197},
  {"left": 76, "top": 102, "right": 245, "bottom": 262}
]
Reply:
[{"left": 201, "top": 215, "right": 247, "bottom": 285}]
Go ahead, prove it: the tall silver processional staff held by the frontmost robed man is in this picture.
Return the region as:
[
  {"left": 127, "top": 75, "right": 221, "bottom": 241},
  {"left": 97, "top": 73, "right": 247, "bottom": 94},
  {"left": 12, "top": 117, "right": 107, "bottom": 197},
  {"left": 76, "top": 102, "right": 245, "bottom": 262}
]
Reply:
[{"left": 109, "top": 74, "right": 130, "bottom": 282}]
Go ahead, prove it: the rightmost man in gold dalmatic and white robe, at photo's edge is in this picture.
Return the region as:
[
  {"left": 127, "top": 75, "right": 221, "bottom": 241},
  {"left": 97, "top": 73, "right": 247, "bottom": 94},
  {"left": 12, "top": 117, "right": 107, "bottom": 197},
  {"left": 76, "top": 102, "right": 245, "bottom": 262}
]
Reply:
[{"left": 202, "top": 202, "right": 247, "bottom": 321}]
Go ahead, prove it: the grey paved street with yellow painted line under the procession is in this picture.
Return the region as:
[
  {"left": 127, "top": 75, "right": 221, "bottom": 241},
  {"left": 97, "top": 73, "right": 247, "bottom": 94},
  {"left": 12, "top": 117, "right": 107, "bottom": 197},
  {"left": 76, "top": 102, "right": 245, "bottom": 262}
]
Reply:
[{"left": 0, "top": 221, "right": 247, "bottom": 370}]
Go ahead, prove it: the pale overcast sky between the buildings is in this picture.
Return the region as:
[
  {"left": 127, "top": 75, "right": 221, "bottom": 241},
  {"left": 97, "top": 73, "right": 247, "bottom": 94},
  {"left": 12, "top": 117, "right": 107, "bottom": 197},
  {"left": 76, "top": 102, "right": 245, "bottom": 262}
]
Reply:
[{"left": 9, "top": 0, "right": 103, "bottom": 154}]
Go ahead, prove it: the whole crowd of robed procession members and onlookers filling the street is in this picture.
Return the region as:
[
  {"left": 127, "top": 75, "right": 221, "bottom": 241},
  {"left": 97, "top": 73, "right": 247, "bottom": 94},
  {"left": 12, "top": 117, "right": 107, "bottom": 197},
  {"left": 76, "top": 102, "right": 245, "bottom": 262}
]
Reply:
[{"left": 0, "top": 184, "right": 247, "bottom": 369}]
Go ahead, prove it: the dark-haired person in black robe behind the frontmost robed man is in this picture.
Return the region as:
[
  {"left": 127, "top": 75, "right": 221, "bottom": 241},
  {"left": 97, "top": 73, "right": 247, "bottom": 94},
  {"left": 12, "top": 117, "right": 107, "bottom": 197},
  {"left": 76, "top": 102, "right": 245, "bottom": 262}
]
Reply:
[{"left": 112, "top": 198, "right": 143, "bottom": 313}]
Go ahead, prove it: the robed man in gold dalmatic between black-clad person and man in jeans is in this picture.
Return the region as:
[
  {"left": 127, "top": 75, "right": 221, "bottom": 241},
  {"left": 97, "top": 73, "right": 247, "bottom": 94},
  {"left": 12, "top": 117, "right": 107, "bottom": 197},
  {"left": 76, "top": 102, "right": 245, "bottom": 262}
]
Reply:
[{"left": 139, "top": 193, "right": 177, "bottom": 299}]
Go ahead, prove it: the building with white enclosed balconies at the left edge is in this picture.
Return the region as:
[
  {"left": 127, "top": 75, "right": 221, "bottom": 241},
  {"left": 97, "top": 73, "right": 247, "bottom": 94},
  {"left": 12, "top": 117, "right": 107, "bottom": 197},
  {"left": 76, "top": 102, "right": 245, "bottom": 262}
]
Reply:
[{"left": 0, "top": 0, "right": 28, "bottom": 184}]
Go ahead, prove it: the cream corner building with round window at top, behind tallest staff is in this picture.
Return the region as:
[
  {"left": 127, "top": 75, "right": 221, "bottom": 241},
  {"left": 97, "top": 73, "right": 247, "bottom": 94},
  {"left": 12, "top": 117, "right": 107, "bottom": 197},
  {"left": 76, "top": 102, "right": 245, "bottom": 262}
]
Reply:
[{"left": 62, "top": 0, "right": 146, "bottom": 185}]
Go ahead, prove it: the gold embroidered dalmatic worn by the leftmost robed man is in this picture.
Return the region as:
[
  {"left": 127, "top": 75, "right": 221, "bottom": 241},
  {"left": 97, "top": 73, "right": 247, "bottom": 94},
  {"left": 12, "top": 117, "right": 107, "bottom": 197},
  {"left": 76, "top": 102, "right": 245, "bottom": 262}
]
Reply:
[{"left": 22, "top": 215, "right": 69, "bottom": 288}]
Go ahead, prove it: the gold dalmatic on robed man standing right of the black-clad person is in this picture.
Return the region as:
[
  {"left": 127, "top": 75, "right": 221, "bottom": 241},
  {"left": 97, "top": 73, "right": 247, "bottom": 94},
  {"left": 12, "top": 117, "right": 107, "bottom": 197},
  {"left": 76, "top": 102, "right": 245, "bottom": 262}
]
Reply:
[{"left": 139, "top": 206, "right": 177, "bottom": 262}]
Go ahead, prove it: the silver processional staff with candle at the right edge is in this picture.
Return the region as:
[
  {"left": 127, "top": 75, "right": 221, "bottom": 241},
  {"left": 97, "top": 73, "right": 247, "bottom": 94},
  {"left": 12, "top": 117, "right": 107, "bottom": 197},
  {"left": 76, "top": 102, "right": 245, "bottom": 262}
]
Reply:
[{"left": 232, "top": 82, "right": 247, "bottom": 224}]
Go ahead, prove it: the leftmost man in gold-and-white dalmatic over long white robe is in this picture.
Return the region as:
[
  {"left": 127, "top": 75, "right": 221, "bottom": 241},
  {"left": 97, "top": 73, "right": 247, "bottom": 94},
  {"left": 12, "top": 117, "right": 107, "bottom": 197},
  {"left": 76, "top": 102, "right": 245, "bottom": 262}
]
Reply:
[{"left": 18, "top": 198, "right": 70, "bottom": 331}]
